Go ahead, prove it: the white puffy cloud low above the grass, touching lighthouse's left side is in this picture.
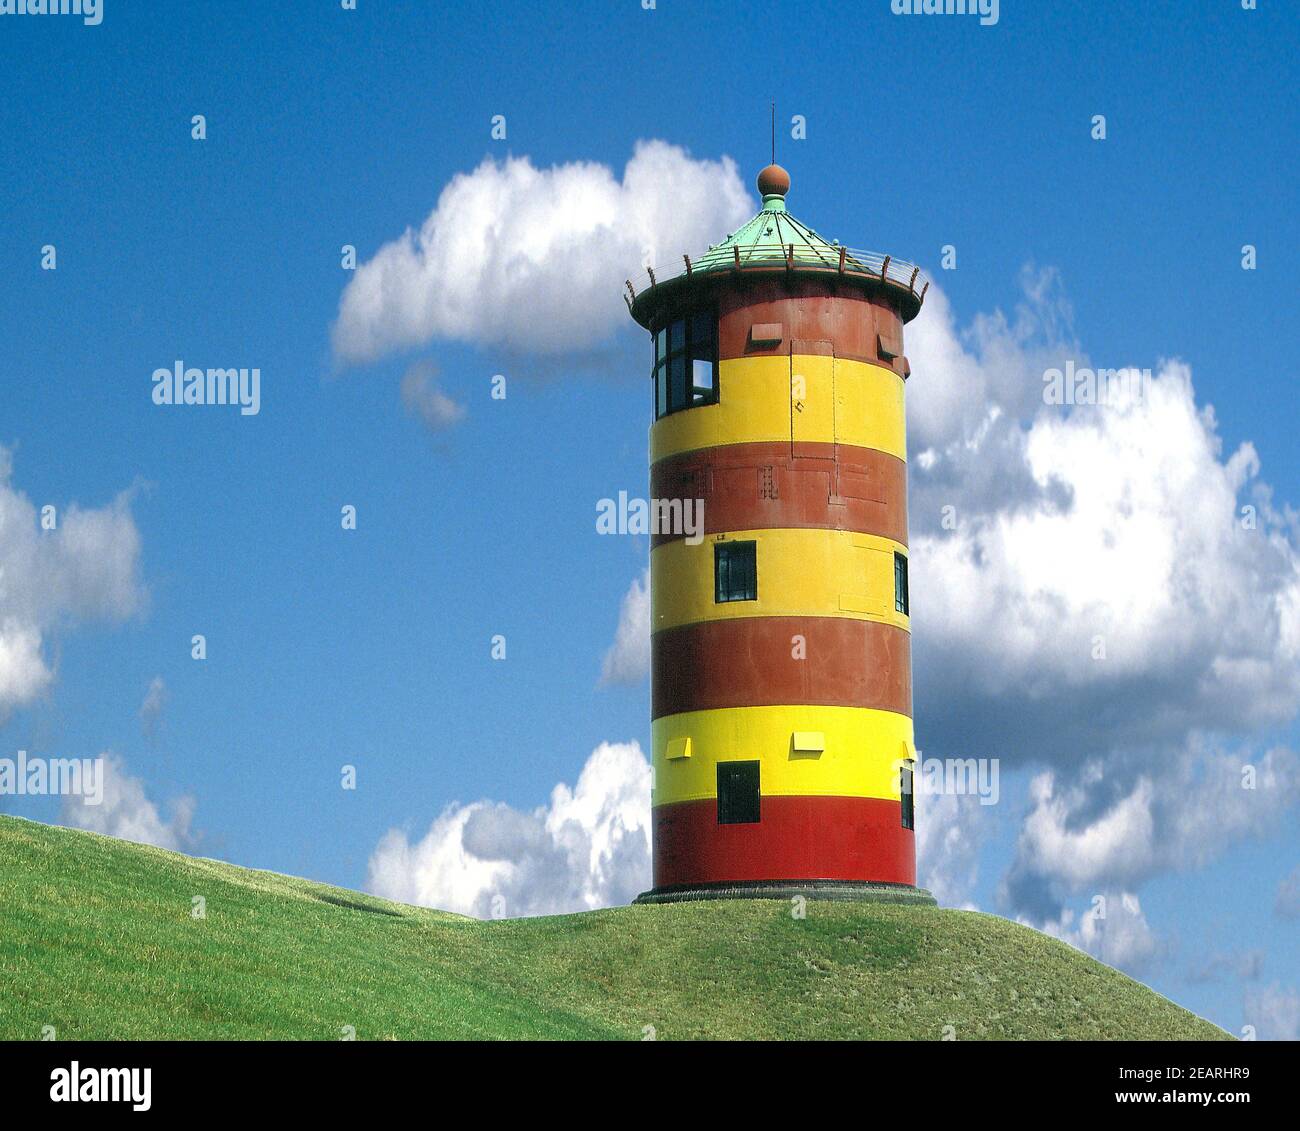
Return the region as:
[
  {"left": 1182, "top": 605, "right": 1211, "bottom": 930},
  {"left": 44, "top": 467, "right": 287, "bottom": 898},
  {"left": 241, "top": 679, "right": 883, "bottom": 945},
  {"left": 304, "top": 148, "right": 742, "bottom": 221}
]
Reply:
[{"left": 367, "top": 742, "right": 650, "bottom": 918}]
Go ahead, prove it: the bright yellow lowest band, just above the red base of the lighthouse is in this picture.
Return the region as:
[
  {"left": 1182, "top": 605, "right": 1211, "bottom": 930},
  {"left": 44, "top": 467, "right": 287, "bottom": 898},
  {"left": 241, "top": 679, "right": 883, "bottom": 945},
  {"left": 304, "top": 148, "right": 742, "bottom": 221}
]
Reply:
[{"left": 650, "top": 706, "right": 917, "bottom": 805}]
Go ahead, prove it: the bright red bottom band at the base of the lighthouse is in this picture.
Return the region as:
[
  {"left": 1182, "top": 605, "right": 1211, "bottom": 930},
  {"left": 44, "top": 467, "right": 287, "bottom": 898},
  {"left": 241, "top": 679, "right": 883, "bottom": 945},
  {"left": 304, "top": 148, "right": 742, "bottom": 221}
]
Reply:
[{"left": 654, "top": 797, "right": 917, "bottom": 888}]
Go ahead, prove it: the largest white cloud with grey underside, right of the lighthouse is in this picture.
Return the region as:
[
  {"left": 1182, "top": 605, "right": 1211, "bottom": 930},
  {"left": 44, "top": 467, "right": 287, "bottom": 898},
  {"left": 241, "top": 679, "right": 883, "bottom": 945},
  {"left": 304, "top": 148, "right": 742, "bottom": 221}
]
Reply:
[{"left": 909, "top": 301, "right": 1300, "bottom": 761}]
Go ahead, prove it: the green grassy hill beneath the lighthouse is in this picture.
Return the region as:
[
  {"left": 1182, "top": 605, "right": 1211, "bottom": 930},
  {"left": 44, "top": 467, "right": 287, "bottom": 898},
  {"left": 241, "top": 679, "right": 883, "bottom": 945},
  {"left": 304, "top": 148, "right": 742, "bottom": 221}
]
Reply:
[{"left": 0, "top": 816, "right": 1227, "bottom": 1040}]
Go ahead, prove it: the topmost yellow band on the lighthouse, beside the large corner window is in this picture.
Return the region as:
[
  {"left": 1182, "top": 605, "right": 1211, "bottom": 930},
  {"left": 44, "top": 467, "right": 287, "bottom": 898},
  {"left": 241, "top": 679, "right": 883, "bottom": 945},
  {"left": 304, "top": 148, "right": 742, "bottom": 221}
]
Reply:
[{"left": 650, "top": 354, "right": 907, "bottom": 463}]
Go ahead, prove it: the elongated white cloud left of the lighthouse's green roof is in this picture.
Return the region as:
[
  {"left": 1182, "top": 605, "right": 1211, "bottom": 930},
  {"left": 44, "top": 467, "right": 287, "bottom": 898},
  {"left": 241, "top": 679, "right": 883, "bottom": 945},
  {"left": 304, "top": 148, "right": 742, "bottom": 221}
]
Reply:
[{"left": 333, "top": 140, "right": 755, "bottom": 364}]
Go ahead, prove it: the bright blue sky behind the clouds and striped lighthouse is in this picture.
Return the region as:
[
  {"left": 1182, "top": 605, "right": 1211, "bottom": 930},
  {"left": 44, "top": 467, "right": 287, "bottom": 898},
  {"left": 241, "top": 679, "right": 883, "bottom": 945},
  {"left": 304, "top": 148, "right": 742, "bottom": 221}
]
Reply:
[{"left": 0, "top": 0, "right": 1300, "bottom": 1036}]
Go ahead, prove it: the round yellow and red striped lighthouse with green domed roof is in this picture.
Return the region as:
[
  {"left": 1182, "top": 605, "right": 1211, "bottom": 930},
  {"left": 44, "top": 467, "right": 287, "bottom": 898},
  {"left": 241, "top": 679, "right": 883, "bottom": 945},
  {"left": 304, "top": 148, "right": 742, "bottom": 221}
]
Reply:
[{"left": 627, "top": 165, "right": 932, "bottom": 902}]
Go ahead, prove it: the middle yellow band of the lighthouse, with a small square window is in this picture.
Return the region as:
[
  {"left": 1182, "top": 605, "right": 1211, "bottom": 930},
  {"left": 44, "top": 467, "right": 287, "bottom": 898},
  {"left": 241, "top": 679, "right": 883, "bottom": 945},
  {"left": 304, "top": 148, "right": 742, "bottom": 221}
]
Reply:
[{"left": 650, "top": 528, "right": 911, "bottom": 634}]
